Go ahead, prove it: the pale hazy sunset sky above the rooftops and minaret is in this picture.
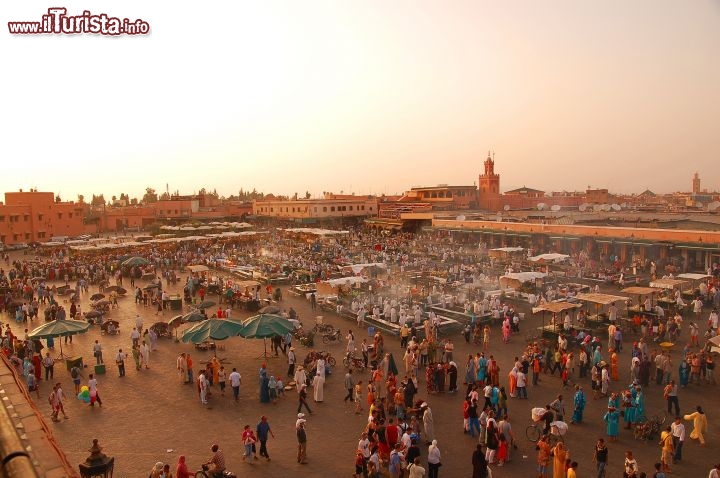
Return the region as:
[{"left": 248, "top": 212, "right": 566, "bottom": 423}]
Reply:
[{"left": 0, "top": 0, "right": 720, "bottom": 200}]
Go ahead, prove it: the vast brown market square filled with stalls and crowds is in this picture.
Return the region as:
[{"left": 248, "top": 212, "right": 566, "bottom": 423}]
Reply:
[{"left": 1, "top": 229, "right": 720, "bottom": 477}]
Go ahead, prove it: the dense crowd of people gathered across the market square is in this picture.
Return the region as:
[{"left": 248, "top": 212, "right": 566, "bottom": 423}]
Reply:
[{"left": 0, "top": 232, "right": 718, "bottom": 478}]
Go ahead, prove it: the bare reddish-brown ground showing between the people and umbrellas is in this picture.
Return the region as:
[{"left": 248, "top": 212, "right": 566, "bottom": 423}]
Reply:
[{"left": 9, "top": 262, "right": 718, "bottom": 478}]
